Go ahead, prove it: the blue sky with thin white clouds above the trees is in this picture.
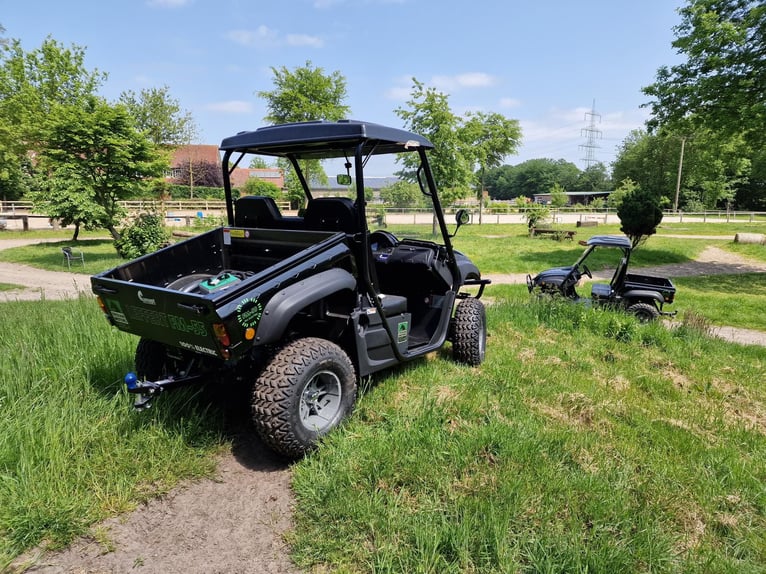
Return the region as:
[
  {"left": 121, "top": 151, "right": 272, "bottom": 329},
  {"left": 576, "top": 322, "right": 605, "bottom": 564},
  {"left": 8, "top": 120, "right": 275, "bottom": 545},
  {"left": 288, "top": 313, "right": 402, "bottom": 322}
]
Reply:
[{"left": 0, "top": 0, "right": 683, "bottom": 175}]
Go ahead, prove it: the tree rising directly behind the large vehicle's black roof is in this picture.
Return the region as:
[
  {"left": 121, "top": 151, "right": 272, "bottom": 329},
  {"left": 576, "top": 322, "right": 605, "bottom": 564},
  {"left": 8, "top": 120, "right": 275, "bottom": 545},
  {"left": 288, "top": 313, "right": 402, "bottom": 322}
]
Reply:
[{"left": 257, "top": 60, "right": 350, "bottom": 204}]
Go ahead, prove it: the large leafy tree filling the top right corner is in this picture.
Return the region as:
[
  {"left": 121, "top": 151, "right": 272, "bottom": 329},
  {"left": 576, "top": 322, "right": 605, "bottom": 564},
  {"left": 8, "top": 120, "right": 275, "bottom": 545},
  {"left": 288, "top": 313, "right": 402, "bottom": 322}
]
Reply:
[{"left": 643, "top": 0, "right": 766, "bottom": 149}]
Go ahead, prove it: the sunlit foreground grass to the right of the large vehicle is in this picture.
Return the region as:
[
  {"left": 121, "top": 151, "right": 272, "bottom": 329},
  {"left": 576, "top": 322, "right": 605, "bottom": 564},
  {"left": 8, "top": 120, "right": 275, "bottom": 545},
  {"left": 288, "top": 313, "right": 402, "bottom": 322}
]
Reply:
[{"left": 291, "top": 296, "right": 766, "bottom": 573}]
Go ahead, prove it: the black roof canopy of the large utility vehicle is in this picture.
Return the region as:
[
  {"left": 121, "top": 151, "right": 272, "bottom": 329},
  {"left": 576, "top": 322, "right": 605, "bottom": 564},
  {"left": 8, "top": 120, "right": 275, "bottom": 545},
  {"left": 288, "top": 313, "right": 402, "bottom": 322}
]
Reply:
[{"left": 220, "top": 120, "right": 434, "bottom": 159}]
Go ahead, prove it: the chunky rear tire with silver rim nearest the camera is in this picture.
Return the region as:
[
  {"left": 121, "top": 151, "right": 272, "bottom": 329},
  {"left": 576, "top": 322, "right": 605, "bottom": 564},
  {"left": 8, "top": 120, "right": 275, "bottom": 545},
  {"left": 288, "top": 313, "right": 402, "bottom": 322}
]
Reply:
[{"left": 251, "top": 337, "right": 356, "bottom": 458}]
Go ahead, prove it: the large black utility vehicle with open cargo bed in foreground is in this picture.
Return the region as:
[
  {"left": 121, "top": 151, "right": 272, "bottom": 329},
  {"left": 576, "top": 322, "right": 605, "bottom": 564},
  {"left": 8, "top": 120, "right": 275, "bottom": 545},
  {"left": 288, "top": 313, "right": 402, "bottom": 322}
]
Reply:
[{"left": 92, "top": 120, "right": 489, "bottom": 456}]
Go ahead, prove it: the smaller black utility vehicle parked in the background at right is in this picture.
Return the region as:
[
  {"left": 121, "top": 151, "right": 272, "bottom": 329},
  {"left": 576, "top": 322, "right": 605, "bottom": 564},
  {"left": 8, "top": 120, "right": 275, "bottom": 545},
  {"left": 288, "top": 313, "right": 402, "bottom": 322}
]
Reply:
[{"left": 527, "top": 235, "right": 676, "bottom": 321}]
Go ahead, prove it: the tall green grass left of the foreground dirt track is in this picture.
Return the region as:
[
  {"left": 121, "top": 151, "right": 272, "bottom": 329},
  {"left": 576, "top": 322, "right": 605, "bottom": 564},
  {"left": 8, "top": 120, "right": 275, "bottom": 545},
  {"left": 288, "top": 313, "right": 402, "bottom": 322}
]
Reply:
[{"left": 0, "top": 297, "right": 222, "bottom": 571}]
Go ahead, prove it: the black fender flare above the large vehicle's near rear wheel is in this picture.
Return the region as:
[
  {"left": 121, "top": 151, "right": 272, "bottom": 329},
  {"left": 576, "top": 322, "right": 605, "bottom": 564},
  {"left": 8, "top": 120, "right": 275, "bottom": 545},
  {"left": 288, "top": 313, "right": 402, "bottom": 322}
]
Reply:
[{"left": 255, "top": 268, "right": 356, "bottom": 344}]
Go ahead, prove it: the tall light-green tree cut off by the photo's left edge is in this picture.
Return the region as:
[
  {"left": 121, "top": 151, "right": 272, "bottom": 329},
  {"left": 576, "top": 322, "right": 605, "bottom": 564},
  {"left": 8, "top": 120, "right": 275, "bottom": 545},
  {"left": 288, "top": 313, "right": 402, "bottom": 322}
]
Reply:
[{"left": 0, "top": 37, "right": 106, "bottom": 198}]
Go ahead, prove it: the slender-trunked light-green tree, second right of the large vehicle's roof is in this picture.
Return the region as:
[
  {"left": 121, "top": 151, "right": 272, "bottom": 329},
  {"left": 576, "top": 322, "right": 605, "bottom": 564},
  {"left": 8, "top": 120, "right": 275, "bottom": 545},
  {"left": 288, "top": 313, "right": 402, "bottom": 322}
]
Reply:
[{"left": 461, "top": 112, "right": 521, "bottom": 223}]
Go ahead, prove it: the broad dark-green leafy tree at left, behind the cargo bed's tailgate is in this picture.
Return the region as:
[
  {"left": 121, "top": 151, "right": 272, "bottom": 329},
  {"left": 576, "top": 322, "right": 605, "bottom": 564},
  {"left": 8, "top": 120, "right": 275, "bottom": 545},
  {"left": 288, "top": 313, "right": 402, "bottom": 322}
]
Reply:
[{"left": 38, "top": 96, "right": 164, "bottom": 239}]
